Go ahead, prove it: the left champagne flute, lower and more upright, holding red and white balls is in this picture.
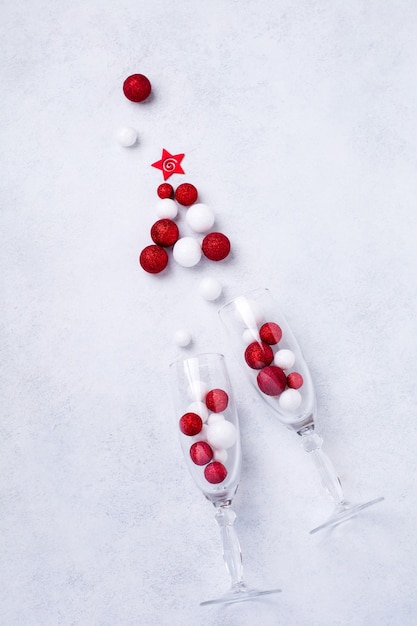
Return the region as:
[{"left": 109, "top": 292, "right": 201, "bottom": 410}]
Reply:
[{"left": 170, "top": 353, "right": 281, "bottom": 605}]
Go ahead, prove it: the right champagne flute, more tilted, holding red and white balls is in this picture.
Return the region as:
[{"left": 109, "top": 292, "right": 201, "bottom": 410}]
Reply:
[{"left": 219, "top": 289, "right": 384, "bottom": 533}]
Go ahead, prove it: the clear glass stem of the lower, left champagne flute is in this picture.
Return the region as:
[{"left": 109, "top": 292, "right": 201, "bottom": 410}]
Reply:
[{"left": 215, "top": 501, "right": 244, "bottom": 589}]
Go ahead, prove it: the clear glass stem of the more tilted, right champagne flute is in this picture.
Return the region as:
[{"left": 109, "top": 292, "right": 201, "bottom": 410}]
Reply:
[{"left": 300, "top": 428, "right": 347, "bottom": 507}]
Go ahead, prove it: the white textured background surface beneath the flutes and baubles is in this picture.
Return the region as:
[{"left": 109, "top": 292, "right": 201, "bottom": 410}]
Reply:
[{"left": 0, "top": 0, "right": 417, "bottom": 626}]
